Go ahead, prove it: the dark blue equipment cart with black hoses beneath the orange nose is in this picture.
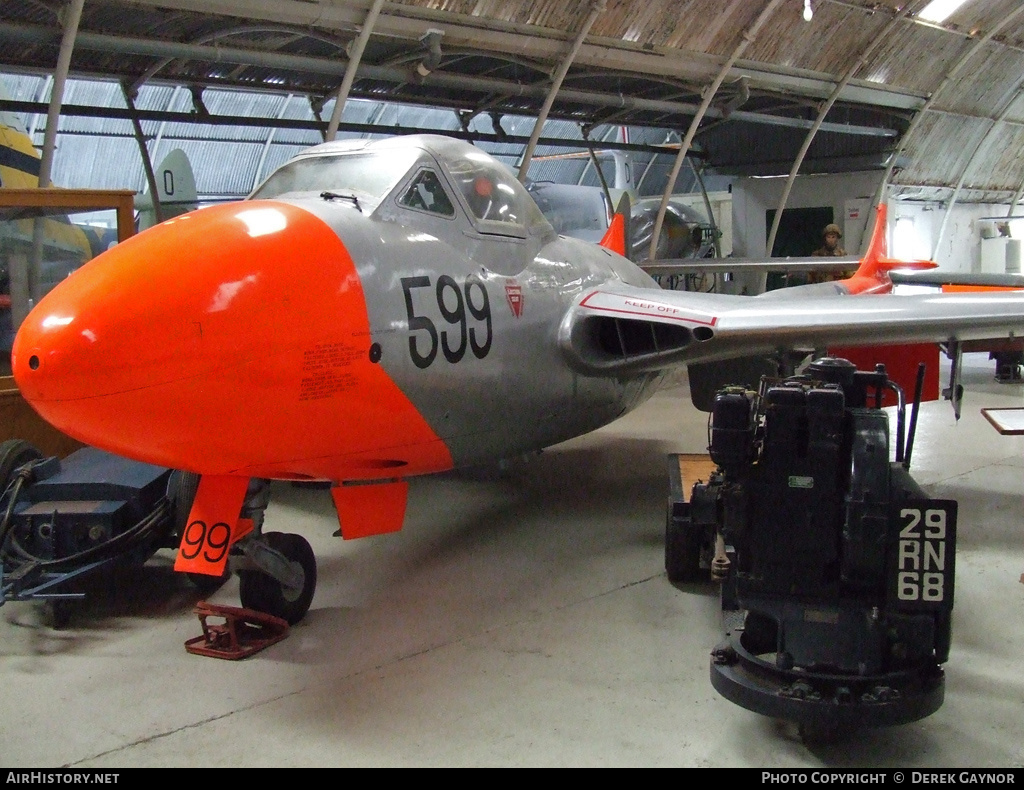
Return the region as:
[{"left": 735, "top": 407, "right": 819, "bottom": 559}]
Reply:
[{"left": 0, "top": 440, "right": 176, "bottom": 622}]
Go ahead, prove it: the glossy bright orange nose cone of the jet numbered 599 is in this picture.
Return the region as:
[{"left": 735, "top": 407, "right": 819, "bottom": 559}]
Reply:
[{"left": 11, "top": 201, "right": 450, "bottom": 477}]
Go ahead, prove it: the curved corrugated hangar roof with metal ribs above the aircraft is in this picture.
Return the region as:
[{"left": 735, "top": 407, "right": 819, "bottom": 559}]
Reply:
[{"left": 0, "top": 0, "right": 1024, "bottom": 202}]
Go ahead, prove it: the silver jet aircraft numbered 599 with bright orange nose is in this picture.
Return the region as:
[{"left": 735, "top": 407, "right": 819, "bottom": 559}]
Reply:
[{"left": 12, "top": 135, "right": 1024, "bottom": 623}]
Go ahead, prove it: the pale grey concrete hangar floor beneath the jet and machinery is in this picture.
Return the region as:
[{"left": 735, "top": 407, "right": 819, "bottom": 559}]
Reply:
[{"left": 0, "top": 355, "right": 1024, "bottom": 767}]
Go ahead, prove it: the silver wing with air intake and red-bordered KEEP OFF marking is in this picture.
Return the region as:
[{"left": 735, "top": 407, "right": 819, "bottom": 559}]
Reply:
[{"left": 558, "top": 285, "right": 1024, "bottom": 376}]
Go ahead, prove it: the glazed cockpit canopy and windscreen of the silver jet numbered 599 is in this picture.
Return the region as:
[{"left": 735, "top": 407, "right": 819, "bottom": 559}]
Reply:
[{"left": 249, "top": 134, "right": 552, "bottom": 236}]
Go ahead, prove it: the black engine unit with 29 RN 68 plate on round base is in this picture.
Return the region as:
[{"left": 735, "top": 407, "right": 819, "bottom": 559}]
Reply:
[{"left": 666, "top": 358, "right": 956, "bottom": 734}]
